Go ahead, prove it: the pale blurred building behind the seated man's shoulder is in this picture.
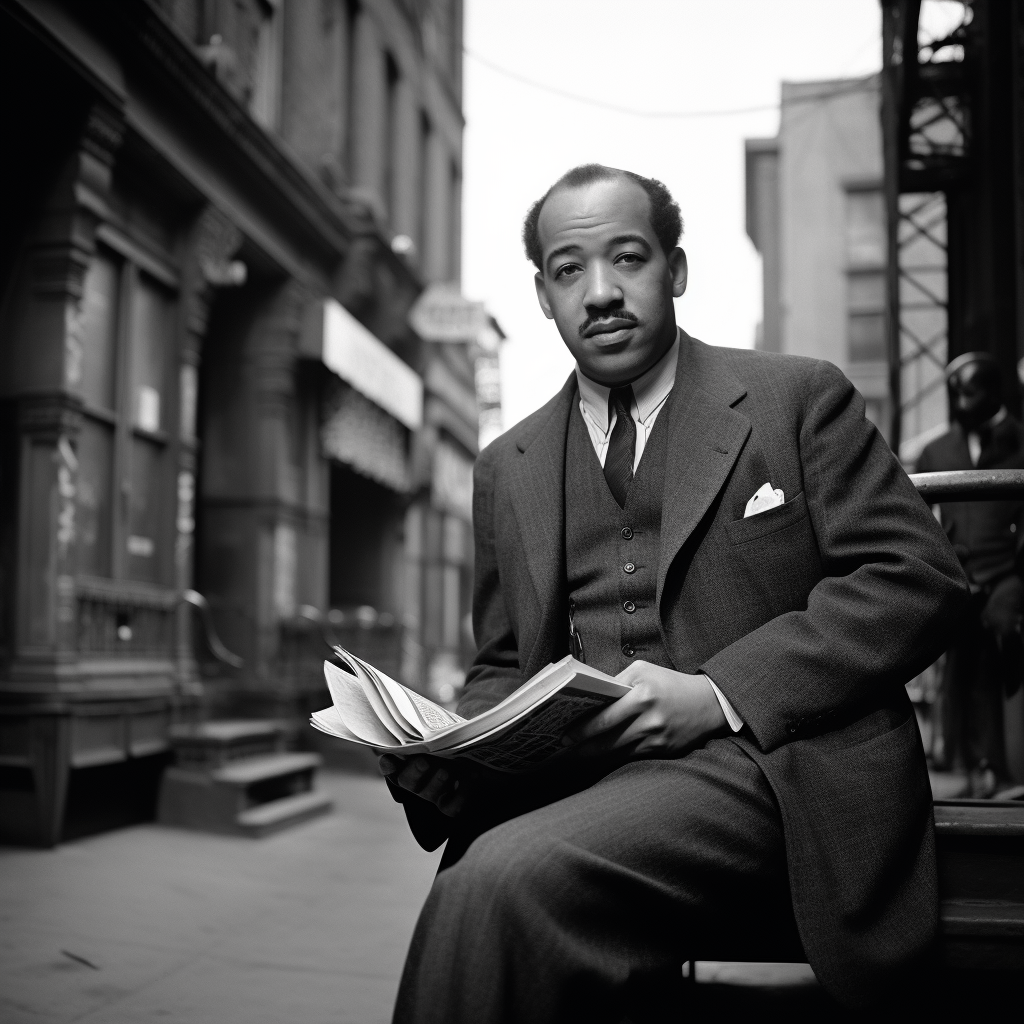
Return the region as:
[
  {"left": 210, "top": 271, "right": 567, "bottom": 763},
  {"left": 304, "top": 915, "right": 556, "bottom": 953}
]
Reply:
[{"left": 746, "top": 69, "right": 890, "bottom": 444}]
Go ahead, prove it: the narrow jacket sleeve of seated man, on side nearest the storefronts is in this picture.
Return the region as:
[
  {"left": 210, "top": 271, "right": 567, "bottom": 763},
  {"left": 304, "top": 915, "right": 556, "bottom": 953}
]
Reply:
[{"left": 459, "top": 447, "right": 522, "bottom": 718}]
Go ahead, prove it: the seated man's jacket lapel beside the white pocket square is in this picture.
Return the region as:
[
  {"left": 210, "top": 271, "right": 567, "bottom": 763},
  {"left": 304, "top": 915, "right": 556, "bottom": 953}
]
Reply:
[{"left": 656, "top": 332, "right": 751, "bottom": 606}]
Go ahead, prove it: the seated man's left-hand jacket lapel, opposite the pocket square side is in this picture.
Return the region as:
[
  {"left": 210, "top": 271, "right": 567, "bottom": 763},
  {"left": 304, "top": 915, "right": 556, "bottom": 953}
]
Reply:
[{"left": 509, "top": 373, "right": 577, "bottom": 678}]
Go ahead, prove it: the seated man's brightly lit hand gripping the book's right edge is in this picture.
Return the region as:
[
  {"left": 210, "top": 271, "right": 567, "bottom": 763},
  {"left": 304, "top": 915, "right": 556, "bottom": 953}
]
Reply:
[{"left": 562, "top": 662, "right": 728, "bottom": 758}]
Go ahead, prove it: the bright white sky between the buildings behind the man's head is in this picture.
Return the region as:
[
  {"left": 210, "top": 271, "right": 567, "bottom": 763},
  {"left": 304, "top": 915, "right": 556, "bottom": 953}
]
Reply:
[{"left": 462, "top": 0, "right": 882, "bottom": 429}]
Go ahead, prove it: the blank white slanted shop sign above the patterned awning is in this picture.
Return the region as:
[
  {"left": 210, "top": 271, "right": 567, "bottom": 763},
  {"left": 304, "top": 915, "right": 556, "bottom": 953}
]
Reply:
[{"left": 317, "top": 299, "right": 423, "bottom": 430}]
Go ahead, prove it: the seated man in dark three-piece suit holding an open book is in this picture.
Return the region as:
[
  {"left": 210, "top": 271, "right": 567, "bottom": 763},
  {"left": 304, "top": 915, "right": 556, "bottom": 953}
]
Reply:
[{"left": 382, "top": 165, "right": 966, "bottom": 1024}]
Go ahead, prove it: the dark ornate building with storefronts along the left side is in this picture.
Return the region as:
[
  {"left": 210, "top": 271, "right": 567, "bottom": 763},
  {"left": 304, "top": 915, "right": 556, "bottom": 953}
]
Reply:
[{"left": 0, "top": 0, "right": 497, "bottom": 843}]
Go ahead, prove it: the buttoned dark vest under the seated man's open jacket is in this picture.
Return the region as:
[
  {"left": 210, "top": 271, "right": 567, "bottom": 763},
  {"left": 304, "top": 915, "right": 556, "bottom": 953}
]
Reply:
[{"left": 565, "top": 394, "right": 673, "bottom": 676}]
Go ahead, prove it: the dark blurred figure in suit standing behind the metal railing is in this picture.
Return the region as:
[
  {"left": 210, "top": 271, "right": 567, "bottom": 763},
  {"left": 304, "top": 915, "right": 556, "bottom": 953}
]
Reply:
[{"left": 918, "top": 352, "right": 1024, "bottom": 798}]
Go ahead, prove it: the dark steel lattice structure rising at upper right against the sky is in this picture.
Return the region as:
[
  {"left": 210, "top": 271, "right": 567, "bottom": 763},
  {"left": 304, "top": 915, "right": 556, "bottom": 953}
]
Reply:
[{"left": 882, "top": 0, "right": 974, "bottom": 462}]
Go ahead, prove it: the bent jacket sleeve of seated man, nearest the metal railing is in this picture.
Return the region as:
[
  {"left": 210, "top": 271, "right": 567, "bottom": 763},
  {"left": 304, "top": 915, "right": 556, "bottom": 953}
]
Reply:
[{"left": 700, "top": 362, "right": 968, "bottom": 753}]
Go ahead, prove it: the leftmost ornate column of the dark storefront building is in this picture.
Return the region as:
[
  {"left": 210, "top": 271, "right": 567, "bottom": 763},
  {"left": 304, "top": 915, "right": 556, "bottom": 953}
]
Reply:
[{"left": 0, "top": 103, "right": 124, "bottom": 846}]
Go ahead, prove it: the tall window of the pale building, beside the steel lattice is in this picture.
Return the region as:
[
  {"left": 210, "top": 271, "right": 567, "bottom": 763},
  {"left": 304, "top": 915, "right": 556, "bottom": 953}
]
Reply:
[{"left": 846, "top": 188, "right": 887, "bottom": 362}]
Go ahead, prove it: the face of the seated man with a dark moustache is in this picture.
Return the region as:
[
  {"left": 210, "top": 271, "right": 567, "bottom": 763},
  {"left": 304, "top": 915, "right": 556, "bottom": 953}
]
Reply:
[{"left": 535, "top": 177, "right": 686, "bottom": 386}]
